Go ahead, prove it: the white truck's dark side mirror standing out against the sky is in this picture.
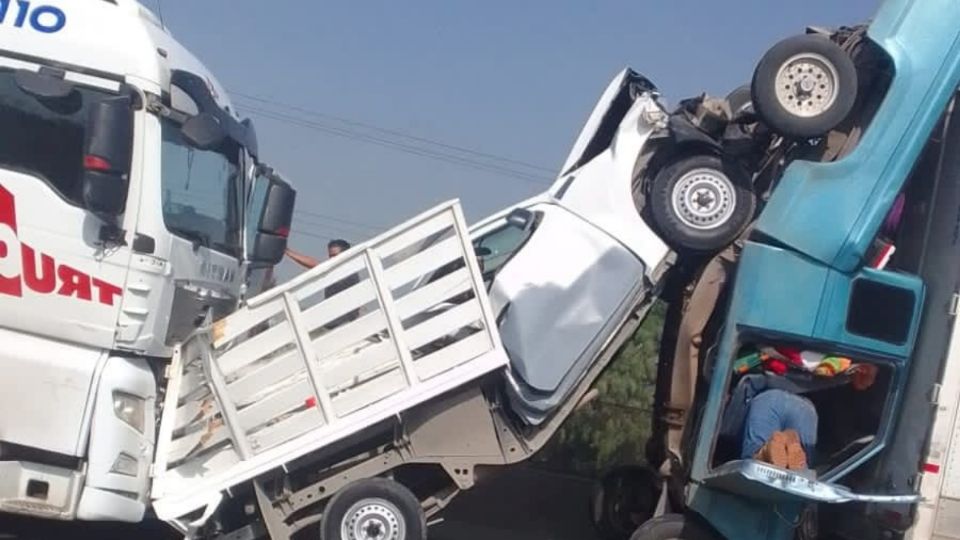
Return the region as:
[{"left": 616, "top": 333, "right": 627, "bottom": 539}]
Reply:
[{"left": 249, "top": 177, "right": 297, "bottom": 266}]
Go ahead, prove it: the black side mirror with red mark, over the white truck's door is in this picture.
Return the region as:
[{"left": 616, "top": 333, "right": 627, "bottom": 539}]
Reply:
[{"left": 83, "top": 96, "right": 133, "bottom": 218}]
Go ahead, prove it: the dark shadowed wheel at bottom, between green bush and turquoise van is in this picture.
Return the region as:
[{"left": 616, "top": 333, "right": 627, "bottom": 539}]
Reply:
[{"left": 590, "top": 467, "right": 661, "bottom": 540}]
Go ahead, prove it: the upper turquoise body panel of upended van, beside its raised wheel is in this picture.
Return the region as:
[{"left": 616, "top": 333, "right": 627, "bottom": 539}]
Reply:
[{"left": 756, "top": 0, "right": 960, "bottom": 272}]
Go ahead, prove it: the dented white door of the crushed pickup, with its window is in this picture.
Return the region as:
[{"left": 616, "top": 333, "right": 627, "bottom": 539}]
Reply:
[{"left": 474, "top": 203, "right": 645, "bottom": 423}]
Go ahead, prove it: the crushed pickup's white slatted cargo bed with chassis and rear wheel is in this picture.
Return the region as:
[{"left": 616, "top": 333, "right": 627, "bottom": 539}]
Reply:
[{"left": 151, "top": 194, "right": 672, "bottom": 539}]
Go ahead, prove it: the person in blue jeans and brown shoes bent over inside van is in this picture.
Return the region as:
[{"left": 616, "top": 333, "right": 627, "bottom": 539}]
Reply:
[{"left": 721, "top": 352, "right": 877, "bottom": 470}]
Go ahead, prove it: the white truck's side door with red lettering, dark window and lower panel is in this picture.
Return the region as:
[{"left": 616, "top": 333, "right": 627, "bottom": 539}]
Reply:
[{"left": 0, "top": 63, "right": 133, "bottom": 455}]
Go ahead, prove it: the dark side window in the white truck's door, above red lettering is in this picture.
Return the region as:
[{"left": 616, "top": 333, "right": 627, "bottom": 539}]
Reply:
[{"left": 0, "top": 70, "right": 115, "bottom": 206}]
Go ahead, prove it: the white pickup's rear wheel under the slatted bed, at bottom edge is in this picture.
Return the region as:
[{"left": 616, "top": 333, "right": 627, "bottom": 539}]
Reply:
[{"left": 320, "top": 478, "right": 427, "bottom": 540}]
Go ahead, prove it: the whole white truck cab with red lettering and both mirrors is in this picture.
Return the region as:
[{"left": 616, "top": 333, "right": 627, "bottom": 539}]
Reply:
[{"left": 0, "top": 0, "right": 294, "bottom": 521}]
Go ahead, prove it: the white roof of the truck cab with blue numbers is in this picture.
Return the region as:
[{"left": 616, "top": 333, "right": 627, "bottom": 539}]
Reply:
[{"left": 0, "top": 0, "right": 233, "bottom": 112}]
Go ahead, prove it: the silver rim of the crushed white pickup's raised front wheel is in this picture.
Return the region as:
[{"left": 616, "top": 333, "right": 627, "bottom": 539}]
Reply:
[{"left": 672, "top": 169, "right": 737, "bottom": 231}]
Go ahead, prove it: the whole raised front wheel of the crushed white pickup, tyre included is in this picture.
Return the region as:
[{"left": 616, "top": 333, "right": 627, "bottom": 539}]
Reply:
[{"left": 649, "top": 154, "right": 757, "bottom": 252}]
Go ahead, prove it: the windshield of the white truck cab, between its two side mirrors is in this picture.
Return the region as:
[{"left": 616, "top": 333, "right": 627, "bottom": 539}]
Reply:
[{"left": 161, "top": 119, "right": 241, "bottom": 256}]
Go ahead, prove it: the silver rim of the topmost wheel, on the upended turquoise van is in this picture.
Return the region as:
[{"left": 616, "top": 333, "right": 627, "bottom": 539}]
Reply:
[{"left": 776, "top": 53, "right": 840, "bottom": 118}]
